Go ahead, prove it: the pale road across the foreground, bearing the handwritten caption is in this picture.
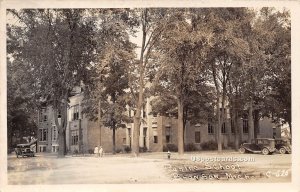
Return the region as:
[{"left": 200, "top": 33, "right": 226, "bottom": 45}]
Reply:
[{"left": 7, "top": 151, "right": 291, "bottom": 185}]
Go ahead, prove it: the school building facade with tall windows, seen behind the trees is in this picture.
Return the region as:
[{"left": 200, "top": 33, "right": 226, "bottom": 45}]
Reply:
[{"left": 38, "top": 92, "right": 281, "bottom": 153}]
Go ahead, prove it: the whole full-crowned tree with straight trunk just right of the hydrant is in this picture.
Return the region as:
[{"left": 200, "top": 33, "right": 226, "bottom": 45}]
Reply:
[{"left": 152, "top": 9, "right": 211, "bottom": 154}]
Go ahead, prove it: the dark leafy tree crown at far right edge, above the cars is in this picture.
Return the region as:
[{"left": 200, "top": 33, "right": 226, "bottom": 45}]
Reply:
[{"left": 256, "top": 8, "right": 292, "bottom": 134}]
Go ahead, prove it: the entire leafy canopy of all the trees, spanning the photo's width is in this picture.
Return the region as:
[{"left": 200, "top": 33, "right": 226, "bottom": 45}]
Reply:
[{"left": 7, "top": 8, "right": 291, "bottom": 155}]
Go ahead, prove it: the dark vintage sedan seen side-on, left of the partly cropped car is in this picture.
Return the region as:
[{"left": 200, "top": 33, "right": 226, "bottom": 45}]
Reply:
[{"left": 240, "top": 138, "right": 276, "bottom": 155}]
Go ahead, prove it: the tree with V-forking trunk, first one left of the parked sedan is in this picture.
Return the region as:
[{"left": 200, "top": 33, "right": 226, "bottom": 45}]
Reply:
[{"left": 207, "top": 8, "right": 253, "bottom": 151}]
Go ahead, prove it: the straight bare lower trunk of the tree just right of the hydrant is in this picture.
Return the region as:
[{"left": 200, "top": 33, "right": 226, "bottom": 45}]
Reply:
[{"left": 177, "top": 97, "right": 184, "bottom": 155}]
